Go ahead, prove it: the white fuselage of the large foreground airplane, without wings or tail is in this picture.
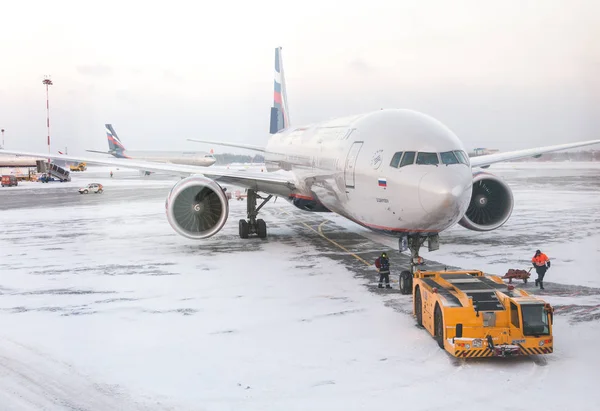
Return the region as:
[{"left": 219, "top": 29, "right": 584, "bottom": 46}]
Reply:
[{"left": 265, "top": 110, "right": 473, "bottom": 235}]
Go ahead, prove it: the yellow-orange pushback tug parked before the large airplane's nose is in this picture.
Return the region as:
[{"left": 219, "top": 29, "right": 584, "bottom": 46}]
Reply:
[{"left": 413, "top": 271, "right": 553, "bottom": 358}]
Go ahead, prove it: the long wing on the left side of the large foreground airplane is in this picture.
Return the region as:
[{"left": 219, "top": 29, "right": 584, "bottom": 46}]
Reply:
[{"left": 0, "top": 150, "right": 296, "bottom": 197}]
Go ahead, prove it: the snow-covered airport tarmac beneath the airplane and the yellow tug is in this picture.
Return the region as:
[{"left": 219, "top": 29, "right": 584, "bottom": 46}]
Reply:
[{"left": 0, "top": 163, "right": 600, "bottom": 410}]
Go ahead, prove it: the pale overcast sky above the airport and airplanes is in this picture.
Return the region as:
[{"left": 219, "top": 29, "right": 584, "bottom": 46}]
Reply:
[{"left": 0, "top": 0, "right": 600, "bottom": 154}]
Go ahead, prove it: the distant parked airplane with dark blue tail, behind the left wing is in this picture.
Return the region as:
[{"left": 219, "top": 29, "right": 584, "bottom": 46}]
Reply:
[{"left": 86, "top": 124, "right": 217, "bottom": 167}]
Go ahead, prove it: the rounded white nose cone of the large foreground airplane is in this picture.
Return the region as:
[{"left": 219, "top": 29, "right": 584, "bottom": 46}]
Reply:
[{"left": 419, "top": 168, "right": 472, "bottom": 218}]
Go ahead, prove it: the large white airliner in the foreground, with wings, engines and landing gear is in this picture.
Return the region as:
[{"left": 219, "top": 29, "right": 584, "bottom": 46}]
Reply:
[{"left": 5, "top": 47, "right": 600, "bottom": 293}]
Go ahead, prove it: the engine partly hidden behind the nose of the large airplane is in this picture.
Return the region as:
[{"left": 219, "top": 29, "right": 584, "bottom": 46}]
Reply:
[{"left": 458, "top": 172, "right": 514, "bottom": 231}]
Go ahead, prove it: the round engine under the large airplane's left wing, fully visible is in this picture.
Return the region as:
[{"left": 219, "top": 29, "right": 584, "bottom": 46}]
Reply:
[{"left": 165, "top": 176, "right": 229, "bottom": 240}]
